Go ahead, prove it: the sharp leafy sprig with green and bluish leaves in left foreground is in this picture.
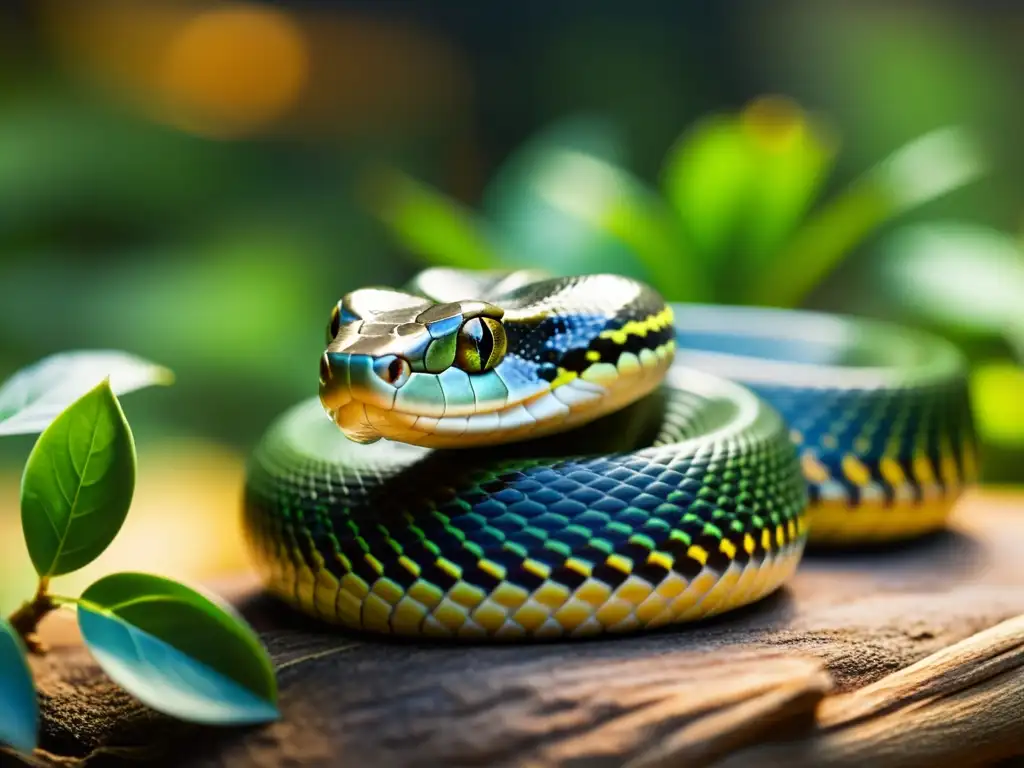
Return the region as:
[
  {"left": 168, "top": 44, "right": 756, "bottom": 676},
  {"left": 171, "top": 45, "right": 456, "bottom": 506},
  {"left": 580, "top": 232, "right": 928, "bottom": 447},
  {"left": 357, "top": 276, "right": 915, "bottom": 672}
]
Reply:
[{"left": 0, "top": 352, "right": 279, "bottom": 753}]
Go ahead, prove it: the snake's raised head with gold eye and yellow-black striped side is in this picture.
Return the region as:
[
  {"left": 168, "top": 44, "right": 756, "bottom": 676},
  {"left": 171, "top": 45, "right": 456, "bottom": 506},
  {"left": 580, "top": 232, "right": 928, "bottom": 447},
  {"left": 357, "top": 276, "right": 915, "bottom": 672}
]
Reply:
[{"left": 319, "top": 272, "right": 674, "bottom": 447}]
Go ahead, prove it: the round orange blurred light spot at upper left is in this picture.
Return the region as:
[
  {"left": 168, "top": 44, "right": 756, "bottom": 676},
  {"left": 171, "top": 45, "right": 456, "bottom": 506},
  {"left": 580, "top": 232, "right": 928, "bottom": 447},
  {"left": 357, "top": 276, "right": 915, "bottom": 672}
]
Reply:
[{"left": 159, "top": 5, "right": 309, "bottom": 136}]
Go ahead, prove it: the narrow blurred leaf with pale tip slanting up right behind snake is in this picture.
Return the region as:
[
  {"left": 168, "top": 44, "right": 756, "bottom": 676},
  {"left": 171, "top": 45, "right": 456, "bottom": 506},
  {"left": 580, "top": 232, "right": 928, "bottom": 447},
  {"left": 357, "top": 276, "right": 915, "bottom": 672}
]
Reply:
[{"left": 751, "top": 128, "right": 985, "bottom": 306}]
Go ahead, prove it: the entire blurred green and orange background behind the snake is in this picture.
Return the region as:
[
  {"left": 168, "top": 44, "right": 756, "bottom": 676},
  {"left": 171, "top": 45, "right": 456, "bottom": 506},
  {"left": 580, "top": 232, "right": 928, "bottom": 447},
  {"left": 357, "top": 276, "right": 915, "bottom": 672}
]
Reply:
[{"left": 0, "top": 0, "right": 1024, "bottom": 609}]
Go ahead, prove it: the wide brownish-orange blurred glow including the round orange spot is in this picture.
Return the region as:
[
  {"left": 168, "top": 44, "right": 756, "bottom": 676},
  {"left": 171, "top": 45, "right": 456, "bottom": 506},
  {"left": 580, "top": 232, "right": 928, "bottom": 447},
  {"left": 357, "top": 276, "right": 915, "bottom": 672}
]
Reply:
[{"left": 41, "top": 0, "right": 470, "bottom": 139}]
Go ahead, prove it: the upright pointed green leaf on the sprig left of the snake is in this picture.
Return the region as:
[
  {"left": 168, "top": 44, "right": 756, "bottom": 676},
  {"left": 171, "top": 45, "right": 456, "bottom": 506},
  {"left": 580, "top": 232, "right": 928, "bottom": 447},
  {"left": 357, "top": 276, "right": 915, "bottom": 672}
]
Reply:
[{"left": 22, "top": 379, "right": 135, "bottom": 579}]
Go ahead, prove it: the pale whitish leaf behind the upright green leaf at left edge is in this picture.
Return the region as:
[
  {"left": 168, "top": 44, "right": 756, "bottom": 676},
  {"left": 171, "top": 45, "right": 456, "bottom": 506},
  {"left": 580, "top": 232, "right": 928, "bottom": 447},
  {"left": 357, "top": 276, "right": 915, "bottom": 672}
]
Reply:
[{"left": 0, "top": 350, "right": 174, "bottom": 435}]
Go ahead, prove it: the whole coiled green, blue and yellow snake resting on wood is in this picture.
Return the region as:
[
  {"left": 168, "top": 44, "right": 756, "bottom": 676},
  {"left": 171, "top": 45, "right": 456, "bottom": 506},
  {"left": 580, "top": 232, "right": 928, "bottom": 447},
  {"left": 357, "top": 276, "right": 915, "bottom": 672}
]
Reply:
[{"left": 243, "top": 267, "right": 977, "bottom": 641}]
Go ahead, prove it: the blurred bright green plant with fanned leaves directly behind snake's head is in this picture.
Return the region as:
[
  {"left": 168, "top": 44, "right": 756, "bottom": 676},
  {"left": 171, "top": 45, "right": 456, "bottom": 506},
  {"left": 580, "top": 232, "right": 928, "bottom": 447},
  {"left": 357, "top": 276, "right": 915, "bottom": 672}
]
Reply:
[{"left": 371, "top": 97, "right": 983, "bottom": 306}]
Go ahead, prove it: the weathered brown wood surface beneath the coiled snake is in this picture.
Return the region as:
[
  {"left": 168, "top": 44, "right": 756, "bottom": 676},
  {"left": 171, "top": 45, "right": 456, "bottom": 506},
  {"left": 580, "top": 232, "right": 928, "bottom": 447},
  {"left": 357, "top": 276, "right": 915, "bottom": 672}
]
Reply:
[{"left": 6, "top": 495, "right": 1024, "bottom": 768}]
